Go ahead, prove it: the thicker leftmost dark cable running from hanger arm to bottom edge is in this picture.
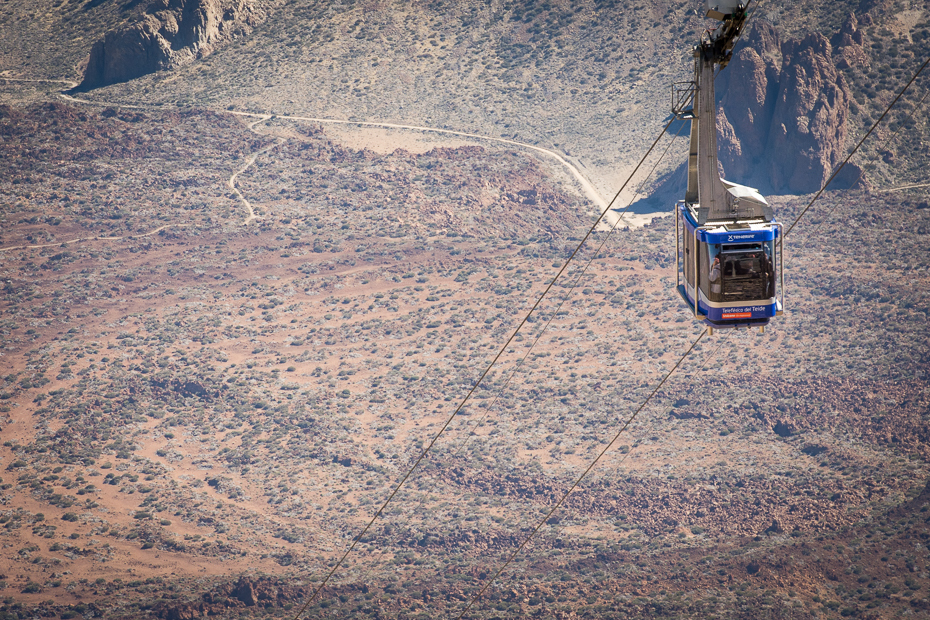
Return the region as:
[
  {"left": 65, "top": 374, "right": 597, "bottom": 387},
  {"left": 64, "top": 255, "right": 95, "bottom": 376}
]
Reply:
[{"left": 286, "top": 119, "right": 674, "bottom": 620}]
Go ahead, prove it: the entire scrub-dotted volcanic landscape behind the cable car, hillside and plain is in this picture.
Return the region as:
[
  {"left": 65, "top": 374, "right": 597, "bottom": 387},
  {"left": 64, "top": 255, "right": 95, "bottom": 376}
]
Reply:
[{"left": 0, "top": 0, "right": 930, "bottom": 620}]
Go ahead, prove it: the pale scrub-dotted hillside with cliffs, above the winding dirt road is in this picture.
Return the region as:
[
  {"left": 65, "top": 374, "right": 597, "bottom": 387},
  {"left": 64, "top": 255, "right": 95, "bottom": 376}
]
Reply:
[{"left": 0, "top": 0, "right": 930, "bottom": 195}]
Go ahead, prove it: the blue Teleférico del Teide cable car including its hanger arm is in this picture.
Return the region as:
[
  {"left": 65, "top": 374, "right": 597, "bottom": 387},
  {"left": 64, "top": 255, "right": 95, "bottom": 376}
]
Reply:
[{"left": 672, "top": 0, "right": 785, "bottom": 333}]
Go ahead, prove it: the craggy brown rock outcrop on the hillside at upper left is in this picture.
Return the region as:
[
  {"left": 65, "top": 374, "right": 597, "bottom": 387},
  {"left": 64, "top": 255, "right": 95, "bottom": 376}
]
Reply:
[{"left": 80, "top": 0, "right": 266, "bottom": 90}]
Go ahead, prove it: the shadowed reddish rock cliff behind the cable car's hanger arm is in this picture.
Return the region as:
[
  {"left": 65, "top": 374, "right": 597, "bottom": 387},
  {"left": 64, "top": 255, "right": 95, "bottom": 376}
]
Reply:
[{"left": 718, "top": 16, "right": 867, "bottom": 193}]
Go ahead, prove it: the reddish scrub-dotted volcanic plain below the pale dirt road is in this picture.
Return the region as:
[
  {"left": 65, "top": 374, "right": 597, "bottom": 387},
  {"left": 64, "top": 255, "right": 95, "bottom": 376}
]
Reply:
[{"left": 0, "top": 104, "right": 930, "bottom": 620}]
